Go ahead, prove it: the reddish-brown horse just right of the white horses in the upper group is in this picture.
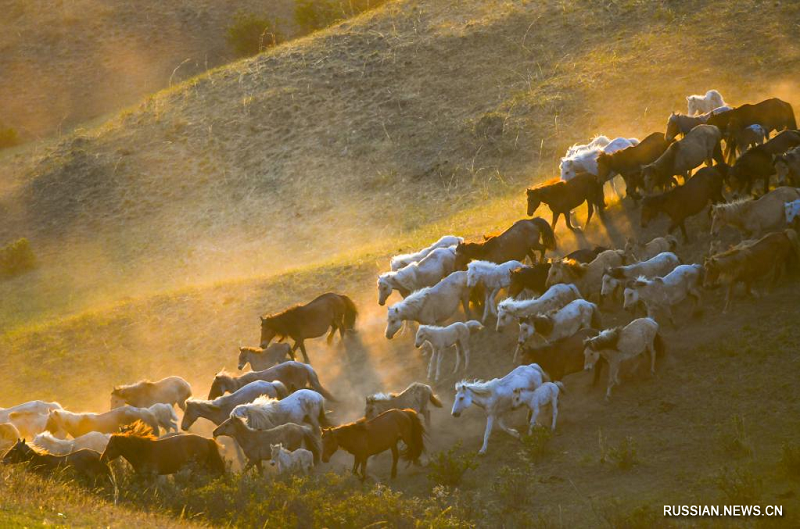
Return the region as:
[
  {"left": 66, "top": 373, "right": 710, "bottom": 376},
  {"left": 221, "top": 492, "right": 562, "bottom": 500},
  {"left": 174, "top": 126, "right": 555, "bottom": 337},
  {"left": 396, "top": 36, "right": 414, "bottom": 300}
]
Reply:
[{"left": 597, "top": 132, "right": 672, "bottom": 200}]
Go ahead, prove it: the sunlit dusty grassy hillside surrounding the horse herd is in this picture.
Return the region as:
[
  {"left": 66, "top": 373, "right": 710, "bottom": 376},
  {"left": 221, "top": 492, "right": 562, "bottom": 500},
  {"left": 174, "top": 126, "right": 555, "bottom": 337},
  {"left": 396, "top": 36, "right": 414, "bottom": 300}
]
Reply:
[{"left": 0, "top": 1, "right": 800, "bottom": 527}]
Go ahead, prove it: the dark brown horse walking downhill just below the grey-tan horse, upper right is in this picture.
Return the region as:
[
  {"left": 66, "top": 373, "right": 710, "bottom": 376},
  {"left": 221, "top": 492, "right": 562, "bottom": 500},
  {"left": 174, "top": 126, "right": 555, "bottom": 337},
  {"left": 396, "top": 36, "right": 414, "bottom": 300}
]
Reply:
[{"left": 641, "top": 164, "right": 728, "bottom": 242}]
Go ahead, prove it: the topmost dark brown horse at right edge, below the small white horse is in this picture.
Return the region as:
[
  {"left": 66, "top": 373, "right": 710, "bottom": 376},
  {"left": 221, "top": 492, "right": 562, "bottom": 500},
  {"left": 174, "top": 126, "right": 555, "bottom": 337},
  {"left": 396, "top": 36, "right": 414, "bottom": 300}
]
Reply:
[{"left": 707, "top": 98, "right": 797, "bottom": 160}]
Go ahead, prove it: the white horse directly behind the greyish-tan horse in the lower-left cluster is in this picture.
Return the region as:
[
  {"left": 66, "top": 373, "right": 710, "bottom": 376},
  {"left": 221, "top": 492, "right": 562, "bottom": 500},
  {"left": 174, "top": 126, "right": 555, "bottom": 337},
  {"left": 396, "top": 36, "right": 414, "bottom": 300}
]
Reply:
[{"left": 231, "top": 389, "right": 328, "bottom": 430}]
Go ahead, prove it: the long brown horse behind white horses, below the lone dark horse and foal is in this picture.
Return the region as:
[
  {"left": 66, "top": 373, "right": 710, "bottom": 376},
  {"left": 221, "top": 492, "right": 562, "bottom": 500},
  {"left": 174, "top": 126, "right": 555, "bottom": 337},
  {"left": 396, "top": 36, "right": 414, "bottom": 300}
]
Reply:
[{"left": 208, "top": 360, "right": 336, "bottom": 401}]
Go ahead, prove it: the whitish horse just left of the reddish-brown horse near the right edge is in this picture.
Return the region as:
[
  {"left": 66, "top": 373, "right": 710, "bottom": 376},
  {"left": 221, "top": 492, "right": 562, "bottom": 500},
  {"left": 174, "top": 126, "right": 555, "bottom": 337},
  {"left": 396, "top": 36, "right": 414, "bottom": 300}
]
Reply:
[{"left": 623, "top": 264, "right": 704, "bottom": 326}]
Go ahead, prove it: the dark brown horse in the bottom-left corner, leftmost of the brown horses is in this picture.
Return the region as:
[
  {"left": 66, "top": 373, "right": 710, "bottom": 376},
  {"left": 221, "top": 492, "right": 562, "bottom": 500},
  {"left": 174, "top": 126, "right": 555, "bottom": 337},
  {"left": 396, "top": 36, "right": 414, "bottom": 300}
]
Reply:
[{"left": 2, "top": 439, "right": 111, "bottom": 480}]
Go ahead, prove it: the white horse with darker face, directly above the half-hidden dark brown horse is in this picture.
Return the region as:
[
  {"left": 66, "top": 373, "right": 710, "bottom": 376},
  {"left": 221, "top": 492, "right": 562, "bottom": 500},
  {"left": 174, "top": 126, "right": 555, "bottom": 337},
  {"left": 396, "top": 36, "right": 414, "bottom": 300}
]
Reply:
[{"left": 517, "top": 299, "right": 600, "bottom": 348}]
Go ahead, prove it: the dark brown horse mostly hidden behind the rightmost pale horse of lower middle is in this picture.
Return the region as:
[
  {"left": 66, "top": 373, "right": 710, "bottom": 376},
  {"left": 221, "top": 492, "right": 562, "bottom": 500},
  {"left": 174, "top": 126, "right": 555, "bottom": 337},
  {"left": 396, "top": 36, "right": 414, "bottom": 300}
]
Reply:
[{"left": 520, "top": 329, "right": 605, "bottom": 385}]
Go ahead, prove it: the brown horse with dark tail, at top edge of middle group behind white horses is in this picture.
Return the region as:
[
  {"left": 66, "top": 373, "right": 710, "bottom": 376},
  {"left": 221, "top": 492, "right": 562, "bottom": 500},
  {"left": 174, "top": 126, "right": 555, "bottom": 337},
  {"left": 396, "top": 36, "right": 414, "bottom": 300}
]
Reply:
[{"left": 455, "top": 217, "right": 556, "bottom": 270}]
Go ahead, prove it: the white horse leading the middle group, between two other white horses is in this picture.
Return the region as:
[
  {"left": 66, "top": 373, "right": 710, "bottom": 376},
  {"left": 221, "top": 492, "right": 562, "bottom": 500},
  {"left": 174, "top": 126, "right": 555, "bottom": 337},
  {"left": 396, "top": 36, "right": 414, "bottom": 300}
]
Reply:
[{"left": 378, "top": 246, "right": 456, "bottom": 306}]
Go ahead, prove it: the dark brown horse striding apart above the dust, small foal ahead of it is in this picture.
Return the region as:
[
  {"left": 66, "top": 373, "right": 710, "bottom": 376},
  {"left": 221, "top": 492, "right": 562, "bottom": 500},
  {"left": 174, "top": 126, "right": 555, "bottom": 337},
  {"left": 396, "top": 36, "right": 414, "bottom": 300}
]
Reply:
[{"left": 261, "top": 292, "right": 358, "bottom": 364}]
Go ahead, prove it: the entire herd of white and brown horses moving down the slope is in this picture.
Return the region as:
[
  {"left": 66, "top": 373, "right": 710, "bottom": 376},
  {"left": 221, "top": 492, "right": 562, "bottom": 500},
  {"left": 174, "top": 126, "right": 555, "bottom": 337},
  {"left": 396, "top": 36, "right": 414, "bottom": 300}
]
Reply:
[{"left": 0, "top": 90, "right": 800, "bottom": 486}]
